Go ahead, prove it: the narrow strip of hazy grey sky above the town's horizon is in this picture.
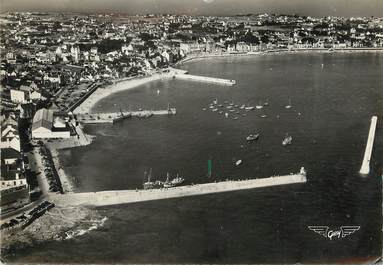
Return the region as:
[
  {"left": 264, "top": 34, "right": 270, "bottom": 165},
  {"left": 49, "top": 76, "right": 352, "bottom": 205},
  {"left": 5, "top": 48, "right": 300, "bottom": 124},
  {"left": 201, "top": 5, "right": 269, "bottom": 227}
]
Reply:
[{"left": 0, "top": 0, "right": 383, "bottom": 17}]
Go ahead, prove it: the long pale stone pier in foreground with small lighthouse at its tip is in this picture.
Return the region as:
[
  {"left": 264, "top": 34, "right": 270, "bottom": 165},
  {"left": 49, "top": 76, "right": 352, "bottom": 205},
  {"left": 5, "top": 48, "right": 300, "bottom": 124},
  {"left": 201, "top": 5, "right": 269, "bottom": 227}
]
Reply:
[{"left": 49, "top": 167, "right": 307, "bottom": 206}]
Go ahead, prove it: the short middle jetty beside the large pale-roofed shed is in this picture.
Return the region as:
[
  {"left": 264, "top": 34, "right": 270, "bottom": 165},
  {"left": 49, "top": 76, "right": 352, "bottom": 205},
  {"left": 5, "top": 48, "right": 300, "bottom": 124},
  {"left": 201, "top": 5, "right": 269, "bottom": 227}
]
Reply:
[{"left": 76, "top": 108, "right": 177, "bottom": 124}]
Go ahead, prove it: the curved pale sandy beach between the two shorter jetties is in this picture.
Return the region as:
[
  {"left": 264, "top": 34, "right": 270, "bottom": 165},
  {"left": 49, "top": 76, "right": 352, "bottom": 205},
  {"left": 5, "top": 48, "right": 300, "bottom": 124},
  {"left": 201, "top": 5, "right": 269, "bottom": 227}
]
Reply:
[{"left": 73, "top": 68, "right": 185, "bottom": 114}]
